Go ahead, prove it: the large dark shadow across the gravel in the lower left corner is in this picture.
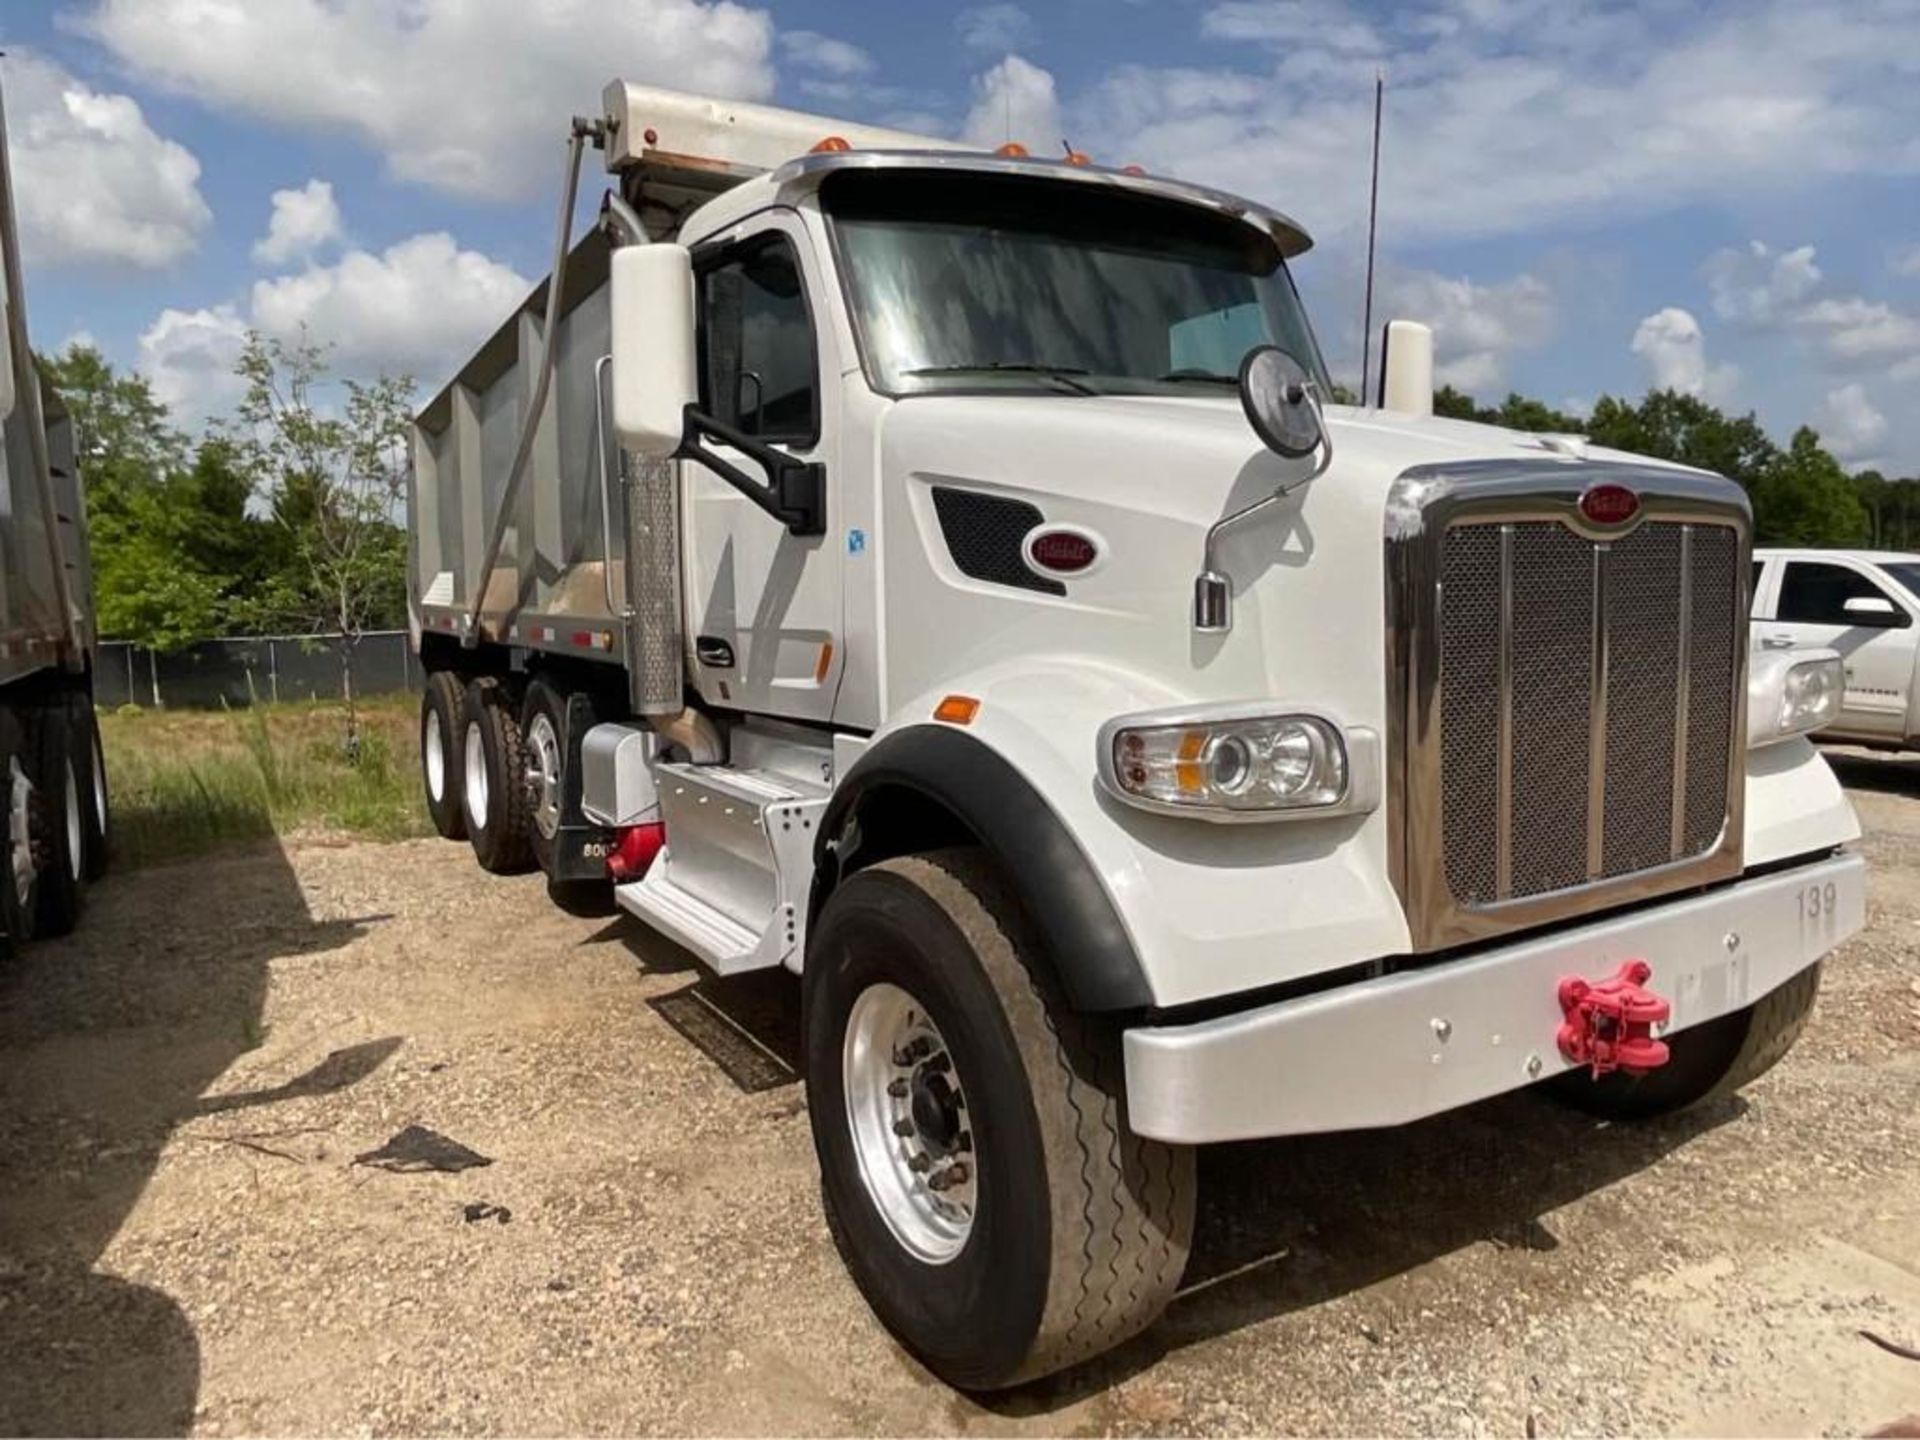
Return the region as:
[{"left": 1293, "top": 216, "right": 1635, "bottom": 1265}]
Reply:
[{"left": 0, "top": 845, "right": 382, "bottom": 1434}]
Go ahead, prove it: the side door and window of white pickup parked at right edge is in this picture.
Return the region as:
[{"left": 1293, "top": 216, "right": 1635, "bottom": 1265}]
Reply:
[{"left": 1753, "top": 559, "right": 1920, "bottom": 739}]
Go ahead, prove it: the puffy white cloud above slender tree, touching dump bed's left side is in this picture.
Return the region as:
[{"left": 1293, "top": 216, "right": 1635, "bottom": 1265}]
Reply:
[{"left": 252, "top": 232, "right": 532, "bottom": 386}]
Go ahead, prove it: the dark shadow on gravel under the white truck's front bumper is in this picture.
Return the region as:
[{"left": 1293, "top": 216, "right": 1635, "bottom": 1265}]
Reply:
[{"left": 973, "top": 1092, "right": 1745, "bottom": 1417}]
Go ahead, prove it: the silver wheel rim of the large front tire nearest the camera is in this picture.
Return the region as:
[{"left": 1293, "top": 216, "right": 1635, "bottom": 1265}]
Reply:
[{"left": 841, "top": 983, "right": 979, "bottom": 1265}]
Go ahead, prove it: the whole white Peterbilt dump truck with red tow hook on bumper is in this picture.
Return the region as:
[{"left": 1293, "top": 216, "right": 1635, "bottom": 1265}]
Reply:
[{"left": 411, "top": 83, "right": 1864, "bottom": 1388}]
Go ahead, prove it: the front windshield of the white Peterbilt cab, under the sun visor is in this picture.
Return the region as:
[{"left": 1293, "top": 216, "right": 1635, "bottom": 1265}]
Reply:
[{"left": 822, "top": 171, "right": 1327, "bottom": 396}]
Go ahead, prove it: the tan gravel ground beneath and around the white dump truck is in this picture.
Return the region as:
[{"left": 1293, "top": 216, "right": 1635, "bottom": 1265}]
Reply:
[{"left": 0, "top": 758, "right": 1920, "bottom": 1434}]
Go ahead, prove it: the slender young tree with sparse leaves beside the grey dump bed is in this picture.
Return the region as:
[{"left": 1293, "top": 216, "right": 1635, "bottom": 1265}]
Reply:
[{"left": 232, "top": 334, "right": 413, "bottom": 755}]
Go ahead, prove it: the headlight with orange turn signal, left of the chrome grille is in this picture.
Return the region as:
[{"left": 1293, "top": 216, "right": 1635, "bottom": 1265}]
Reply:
[{"left": 1100, "top": 707, "right": 1379, "bottom": 820}]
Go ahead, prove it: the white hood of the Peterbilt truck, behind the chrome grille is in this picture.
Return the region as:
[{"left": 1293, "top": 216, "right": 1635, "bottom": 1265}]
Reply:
[{"left": 879, "top": 396, "right": 1704, "bottom": 724}]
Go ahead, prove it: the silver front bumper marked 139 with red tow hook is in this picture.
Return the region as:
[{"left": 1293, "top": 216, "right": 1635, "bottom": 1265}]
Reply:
[{"left": 1125, "top": 854, "right": 1866, "bottom": 1144}]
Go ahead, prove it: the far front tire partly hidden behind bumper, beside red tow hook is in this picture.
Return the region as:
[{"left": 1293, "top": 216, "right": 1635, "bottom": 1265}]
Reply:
[{"left": 1548, "top": 964, "right": 1820, "bottom": 1119}]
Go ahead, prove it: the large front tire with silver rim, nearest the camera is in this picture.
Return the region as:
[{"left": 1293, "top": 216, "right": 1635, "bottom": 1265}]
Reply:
[{"left": 803, "top": 851, "right": 1196, "bottom": 1390}]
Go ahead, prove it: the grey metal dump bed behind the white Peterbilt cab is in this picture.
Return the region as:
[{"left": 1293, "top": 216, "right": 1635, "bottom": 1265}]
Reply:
[{"left": 409, "top": 81, "right": 950, "bottom": 675}]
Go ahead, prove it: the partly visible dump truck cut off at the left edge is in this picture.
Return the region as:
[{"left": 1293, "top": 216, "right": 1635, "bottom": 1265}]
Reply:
[{"left": 0, "top": 81, "right": 108, "bottom": 952}]
